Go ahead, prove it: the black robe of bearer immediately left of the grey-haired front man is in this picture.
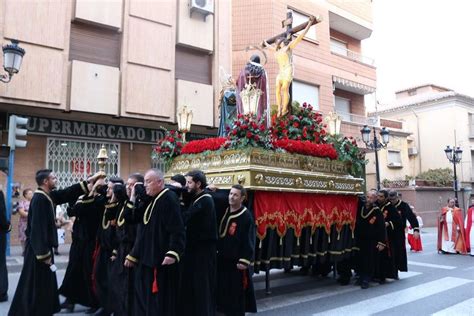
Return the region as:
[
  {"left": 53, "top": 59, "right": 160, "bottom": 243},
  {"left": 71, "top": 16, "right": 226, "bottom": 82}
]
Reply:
[{"left": 110, "top": 201, "right": 136, "bottom": 316}]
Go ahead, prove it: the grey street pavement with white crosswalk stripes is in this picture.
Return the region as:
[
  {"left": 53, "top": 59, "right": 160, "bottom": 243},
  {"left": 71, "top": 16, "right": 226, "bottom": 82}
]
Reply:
[{"left": 0, "top": 228, "right": 474, "bottom": 316}]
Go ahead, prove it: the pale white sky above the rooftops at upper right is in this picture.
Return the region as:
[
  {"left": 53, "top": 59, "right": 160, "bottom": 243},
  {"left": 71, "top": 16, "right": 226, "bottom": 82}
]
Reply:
[{"left": 362, "top": 0, "right": 474, "bottom": 107}]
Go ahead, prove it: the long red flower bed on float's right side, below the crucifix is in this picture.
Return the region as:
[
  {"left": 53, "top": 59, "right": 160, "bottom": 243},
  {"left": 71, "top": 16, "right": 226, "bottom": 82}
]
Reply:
[{"left": 273, "top": 139, "right": 337, "bottom": 160}]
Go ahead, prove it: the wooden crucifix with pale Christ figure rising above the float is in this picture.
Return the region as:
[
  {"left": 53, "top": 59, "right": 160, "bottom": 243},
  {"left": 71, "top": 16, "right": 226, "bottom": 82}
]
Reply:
[{"left": 262, "top": 10, "right": 321, "bottom": 117}]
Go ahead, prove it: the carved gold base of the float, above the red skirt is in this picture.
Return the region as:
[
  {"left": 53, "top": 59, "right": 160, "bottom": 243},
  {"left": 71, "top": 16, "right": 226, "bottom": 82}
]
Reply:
[{"left": 166, "top": 148, "right": 364, "bottom": 195}]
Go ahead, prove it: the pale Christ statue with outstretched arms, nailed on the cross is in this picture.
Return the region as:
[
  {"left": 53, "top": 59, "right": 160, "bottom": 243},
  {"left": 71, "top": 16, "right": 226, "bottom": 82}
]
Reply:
[{"left": 263, "top": 16, "right": 319, "bottom": 117}]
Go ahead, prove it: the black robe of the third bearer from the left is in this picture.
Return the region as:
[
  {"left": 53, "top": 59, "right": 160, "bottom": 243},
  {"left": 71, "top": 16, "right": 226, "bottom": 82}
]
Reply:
[{"left": 92, "top": 202, "right": 119, "bottom": 313}]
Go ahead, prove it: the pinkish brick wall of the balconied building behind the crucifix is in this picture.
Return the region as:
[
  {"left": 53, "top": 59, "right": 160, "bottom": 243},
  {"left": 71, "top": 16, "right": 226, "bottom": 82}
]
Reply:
[{"left": 232, "top": 0, "right": 376, "bottom": 121}]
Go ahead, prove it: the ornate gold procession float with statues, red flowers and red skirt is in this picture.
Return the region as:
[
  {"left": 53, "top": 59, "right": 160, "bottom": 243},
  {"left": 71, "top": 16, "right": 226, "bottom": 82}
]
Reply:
[{"left": 155, "top": 13, "right": 366, "bottom": 290}]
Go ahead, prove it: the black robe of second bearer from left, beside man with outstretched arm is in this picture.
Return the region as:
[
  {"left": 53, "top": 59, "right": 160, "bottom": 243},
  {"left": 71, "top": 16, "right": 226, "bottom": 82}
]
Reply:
[{"left": 59, "top": 195, "right": 105, "bottom": 307}]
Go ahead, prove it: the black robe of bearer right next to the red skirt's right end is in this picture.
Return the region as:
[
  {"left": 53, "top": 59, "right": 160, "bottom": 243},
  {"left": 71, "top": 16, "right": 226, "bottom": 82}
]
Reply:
[{"left": 354, "top": 205, "right": 387, "bottom": 282}]
